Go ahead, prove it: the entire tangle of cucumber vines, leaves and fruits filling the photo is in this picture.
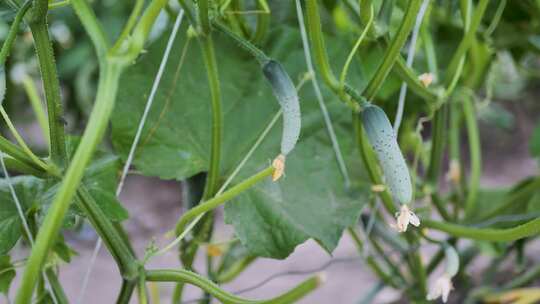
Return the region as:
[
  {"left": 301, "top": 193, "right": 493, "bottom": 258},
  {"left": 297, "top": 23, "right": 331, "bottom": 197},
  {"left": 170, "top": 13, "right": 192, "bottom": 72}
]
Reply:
[{"left": 0, "top": 0, "right": 540, "bottom": 304}]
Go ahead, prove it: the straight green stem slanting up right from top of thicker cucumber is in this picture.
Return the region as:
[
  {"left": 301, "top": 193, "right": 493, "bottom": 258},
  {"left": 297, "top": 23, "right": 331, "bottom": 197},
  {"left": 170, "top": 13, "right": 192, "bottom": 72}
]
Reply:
[{"left": 362, "top": 0, "right": 422, "bottom": 100}]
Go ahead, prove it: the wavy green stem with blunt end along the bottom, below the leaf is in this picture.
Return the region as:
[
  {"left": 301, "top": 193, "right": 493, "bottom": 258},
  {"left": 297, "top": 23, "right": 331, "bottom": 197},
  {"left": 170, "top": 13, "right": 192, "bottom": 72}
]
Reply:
[{"left": 146, "top": 269, "right": 321, "bottom": 304}]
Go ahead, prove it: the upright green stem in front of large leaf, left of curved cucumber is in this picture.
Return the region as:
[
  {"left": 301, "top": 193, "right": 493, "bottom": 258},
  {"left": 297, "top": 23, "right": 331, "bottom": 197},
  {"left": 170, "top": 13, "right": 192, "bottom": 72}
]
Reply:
[{"left": 199, "top": 34, "right": 223, "bottom": 200}]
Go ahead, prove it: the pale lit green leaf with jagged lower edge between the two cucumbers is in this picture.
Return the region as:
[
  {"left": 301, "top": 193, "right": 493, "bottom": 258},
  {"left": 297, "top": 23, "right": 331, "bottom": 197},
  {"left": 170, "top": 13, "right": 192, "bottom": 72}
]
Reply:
[{"left": 225, "top": 126, "right": 367, "bottom": 258}]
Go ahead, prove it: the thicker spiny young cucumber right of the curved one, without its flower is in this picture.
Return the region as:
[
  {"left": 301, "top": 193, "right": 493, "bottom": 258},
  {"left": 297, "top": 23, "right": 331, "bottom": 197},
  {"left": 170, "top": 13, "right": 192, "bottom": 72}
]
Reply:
[{"left": 360, "top": 105, "right": 412, "bottom": 204}]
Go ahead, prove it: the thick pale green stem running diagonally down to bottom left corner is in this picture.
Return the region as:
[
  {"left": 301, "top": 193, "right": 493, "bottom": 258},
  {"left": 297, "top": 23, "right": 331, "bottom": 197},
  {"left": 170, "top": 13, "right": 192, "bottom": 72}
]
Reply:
[{"left": 15, "top": 60, "right": 121, "bottom": 304}]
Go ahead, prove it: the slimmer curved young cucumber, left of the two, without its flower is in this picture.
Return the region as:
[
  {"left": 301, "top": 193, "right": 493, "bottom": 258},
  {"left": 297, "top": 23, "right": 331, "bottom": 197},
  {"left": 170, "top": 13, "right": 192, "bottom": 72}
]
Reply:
[{"left": 262, "top": 60, "right": 302, "bottom": 155}]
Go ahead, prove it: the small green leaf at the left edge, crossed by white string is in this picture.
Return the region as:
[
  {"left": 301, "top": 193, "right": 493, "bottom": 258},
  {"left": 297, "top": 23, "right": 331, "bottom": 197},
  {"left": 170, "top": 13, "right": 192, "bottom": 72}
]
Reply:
[{"left": 0, "top": 176, "right": 44, "bottom": 255}]
